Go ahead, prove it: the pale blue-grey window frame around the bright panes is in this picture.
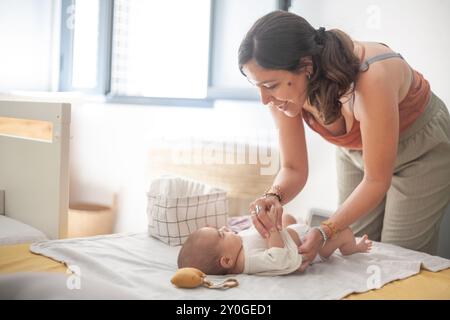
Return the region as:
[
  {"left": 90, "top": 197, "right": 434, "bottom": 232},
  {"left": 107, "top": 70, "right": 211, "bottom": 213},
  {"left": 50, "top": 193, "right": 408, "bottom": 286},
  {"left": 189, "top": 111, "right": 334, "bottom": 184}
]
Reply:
[{"left": 59, "top": 0, "right": 291, "bottom": 108}]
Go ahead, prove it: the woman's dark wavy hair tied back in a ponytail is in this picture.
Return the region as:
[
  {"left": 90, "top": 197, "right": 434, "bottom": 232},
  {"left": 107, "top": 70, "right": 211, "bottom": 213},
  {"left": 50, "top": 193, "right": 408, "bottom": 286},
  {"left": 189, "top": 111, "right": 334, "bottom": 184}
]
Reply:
[{"left": 239, "top": 11, "right": 360, "bottom": 124}]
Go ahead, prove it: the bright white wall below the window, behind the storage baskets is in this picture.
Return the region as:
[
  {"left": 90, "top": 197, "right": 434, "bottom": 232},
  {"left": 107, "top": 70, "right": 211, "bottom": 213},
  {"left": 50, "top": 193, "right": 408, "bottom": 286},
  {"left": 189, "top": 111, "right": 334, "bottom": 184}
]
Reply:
[{"left": 70, "top": 101, "right": 274, "bottom": 232}]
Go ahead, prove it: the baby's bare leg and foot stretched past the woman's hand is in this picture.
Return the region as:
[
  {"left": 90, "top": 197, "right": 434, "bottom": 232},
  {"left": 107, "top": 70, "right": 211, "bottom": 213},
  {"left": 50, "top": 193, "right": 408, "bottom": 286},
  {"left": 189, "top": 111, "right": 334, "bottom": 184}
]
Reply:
[{"left": 319, "top": 228, "right": 372, "bottom": 258}]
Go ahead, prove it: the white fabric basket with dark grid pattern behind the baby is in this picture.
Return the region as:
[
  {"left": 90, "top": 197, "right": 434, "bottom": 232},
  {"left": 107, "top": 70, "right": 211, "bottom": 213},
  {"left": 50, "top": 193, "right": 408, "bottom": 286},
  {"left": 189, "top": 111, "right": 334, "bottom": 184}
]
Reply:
[{"left": 147, "top": 175, "right": 228, "bottom": 246}]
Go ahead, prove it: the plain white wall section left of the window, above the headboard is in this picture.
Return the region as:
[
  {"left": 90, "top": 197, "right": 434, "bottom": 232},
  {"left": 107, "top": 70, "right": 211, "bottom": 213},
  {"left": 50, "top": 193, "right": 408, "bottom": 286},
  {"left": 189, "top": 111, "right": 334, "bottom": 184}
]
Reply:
[{"left": 0, "top": 0, "right": 56, "bottom": 92}]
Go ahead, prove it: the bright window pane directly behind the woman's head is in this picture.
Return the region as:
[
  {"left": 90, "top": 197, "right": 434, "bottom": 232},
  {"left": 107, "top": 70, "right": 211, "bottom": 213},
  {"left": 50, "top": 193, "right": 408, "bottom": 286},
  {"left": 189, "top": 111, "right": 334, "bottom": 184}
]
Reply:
[{"left": 212, "top": 0, "right": 278, "bottom": 88}]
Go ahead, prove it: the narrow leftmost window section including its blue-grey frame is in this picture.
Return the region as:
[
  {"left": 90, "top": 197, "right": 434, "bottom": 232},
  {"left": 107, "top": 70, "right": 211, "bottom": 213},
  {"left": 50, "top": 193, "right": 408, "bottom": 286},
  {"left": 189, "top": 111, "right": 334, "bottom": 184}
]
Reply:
[{"left": 59, "top": 0, "right": 113, "bottom": 94}]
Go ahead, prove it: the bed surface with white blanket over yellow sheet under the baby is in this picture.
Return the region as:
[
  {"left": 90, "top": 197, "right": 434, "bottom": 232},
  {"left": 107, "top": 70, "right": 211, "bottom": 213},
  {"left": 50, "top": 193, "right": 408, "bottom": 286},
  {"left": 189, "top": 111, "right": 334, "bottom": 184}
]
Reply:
[{"left": 0, "top": 232, "right": 450, "bottom": 300}]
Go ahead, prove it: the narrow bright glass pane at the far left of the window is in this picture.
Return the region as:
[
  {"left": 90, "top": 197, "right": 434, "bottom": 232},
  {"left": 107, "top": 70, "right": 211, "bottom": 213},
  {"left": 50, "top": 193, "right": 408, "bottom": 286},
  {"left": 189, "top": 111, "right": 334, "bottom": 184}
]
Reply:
[{"left": 72, "top": 0, "right": 99, "bottom": 89}]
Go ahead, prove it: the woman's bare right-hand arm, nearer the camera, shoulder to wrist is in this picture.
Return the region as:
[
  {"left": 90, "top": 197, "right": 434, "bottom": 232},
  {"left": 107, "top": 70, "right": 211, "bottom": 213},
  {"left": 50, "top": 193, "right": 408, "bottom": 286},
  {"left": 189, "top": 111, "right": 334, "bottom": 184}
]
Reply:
[{"left": 330, "top": 65, "right": 399, "bottom": 230}]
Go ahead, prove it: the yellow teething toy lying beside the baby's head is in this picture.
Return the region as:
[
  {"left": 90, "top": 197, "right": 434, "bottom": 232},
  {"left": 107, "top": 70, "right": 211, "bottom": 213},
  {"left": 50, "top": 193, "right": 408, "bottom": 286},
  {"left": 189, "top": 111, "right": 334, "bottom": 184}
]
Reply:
[{"left": 170, "top": 268, "right": 239, "bottom": 289}]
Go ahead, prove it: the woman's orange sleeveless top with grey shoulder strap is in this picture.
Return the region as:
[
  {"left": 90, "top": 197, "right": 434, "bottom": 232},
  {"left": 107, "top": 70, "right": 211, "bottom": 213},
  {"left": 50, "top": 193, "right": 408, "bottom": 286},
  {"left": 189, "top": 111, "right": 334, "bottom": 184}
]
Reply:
[{"left": 302, "top": 45, "right": 431, "bottom": 150}]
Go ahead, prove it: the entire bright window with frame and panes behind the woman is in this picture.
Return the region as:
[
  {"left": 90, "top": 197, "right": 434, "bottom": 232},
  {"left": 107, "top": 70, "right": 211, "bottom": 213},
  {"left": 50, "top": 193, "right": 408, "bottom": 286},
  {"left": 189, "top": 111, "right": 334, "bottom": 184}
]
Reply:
[{"left": 60, "top": 0, "right": 289, "bottom": 106}]
